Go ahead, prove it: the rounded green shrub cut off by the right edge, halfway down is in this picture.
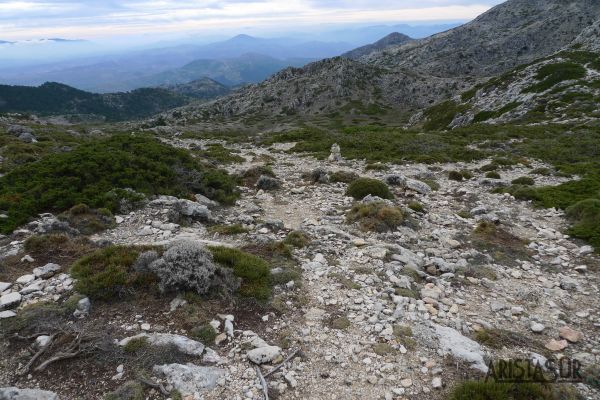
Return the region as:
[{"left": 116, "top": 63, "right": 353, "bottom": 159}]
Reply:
[{"left": 567, "top": 199, "right": 600, "bottom": 250}]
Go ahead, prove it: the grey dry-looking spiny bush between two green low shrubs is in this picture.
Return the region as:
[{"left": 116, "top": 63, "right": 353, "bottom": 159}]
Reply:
[{"left": 148, "top": 240, "right": 239, "bottom": 295}]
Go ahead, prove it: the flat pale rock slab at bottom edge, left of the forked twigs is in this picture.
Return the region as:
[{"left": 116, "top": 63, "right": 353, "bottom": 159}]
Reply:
[{"left": 152, "top": 364, "right": 226, "bottom": 397}]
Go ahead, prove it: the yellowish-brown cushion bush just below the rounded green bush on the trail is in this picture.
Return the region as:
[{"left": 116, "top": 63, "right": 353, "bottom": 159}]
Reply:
[{"left": 346, "top": 202, "right": 404, "bottom": 232}]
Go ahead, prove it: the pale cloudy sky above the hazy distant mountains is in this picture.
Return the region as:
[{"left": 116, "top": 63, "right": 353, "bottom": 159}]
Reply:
[{"left": 0, "top": 0, "right": 502, "bottom": 40}]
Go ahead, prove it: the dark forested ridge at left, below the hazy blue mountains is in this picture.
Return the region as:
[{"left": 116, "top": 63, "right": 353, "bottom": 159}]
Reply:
[{"left": 0, "top": 82, "right": 191, "bottom": 122}]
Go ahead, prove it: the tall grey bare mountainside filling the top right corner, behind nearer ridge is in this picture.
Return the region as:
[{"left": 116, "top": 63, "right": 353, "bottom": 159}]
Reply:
[{"left": 364, "top": 0, "right": 600, "bottom": 77}]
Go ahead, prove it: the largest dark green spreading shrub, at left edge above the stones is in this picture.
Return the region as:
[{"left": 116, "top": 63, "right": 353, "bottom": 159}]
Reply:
[{"left": 0, "top": 135, "right": 239, "bottom": 233}]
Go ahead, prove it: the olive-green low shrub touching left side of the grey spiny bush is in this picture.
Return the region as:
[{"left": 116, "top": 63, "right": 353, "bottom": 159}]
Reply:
[{"left": 71, "top": 246, "right": 158, "bottom": 300}]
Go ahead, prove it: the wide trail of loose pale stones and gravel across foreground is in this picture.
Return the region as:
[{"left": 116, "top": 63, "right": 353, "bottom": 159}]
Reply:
[{"left": 0, "top": 139, "right": 600, "bottom": 400}]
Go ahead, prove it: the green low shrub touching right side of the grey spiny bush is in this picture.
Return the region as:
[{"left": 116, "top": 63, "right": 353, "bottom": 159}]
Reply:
[{"left": 210, "top": 247, "right": 271, "bottom": 300}]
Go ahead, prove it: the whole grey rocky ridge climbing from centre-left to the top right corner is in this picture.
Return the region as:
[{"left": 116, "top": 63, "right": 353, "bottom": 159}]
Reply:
[{"left": 171, "top": 0, "right": 600, "bottom": 122}]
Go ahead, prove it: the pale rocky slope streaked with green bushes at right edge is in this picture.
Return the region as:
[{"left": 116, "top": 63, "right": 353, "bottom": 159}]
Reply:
[{"left": 414, "top": 49, "right": 600, "bottom": 128}]
